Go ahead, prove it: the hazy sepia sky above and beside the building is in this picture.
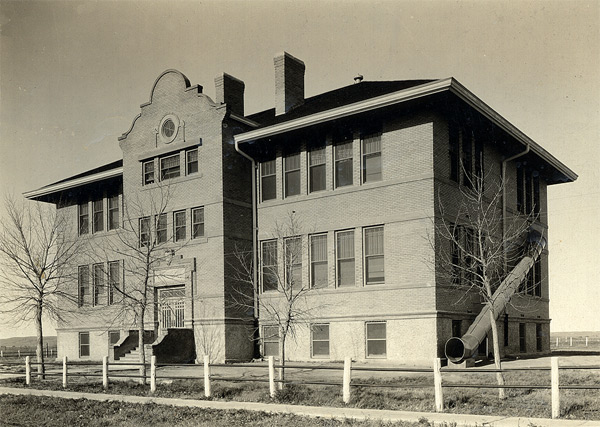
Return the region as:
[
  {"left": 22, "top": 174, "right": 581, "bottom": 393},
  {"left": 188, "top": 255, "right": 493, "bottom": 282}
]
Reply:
[{"left": 0, "top": 0, "right": 600, "bottom": 338}]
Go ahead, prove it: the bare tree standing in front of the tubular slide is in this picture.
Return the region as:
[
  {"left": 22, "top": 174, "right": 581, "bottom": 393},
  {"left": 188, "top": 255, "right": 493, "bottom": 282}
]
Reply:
[{"left": 429, "top": 171, "right": 535, "bottom": 399}]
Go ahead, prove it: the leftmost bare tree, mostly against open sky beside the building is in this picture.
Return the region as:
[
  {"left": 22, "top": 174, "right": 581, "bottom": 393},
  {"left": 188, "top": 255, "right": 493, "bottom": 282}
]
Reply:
[{"left": 0, "top": 197, "right": 81, "bottom": 375}]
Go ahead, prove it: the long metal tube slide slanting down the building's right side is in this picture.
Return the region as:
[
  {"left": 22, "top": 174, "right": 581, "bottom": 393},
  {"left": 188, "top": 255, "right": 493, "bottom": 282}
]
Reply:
[{"left": 445, "top": 230, "right": 546, "bottom": 363}]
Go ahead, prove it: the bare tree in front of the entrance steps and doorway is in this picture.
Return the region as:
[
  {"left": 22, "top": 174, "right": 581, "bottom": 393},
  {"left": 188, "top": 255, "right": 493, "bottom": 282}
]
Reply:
[{"left": 95, "top": 183, "right": 185, "bottom": 383}]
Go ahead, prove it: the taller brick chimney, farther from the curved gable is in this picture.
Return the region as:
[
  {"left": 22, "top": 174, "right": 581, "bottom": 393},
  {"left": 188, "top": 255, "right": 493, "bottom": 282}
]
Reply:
[{"left": 273, "top": 52, "right": 305, "bottom": 116}]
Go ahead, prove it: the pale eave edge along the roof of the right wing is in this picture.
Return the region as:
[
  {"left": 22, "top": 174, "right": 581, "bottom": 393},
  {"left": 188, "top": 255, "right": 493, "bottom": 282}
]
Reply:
[{"left": 234, "top": 77, "right": 577, "bottom": 181}]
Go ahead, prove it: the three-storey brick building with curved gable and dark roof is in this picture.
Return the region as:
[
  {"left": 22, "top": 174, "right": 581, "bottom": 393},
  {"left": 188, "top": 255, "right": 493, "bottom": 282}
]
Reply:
[{"left": 25, "top": 53, "right": 577, "bottom": 363}]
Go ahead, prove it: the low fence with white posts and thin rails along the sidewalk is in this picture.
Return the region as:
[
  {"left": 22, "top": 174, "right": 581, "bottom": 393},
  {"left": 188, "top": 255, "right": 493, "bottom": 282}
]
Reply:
[{"left": 0, "top": 356, "right": 600, "bottom": 418}]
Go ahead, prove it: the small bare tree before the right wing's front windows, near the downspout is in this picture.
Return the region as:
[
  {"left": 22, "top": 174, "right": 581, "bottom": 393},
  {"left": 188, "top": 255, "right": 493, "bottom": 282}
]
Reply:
[{"left": 233, "top": 212, "right": 322, "bottom": 389}]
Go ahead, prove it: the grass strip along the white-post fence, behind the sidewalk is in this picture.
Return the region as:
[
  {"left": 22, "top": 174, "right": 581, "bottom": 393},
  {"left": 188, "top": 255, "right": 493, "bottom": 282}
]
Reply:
[{"left": 0, "top": 371, "right": 600, "bottom": 420}]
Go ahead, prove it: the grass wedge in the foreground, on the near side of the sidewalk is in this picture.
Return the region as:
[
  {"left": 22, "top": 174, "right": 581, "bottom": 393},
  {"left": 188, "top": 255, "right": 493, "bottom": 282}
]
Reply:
[{"left": 0, "top": 395, "right": 429, "bottom": 427}]
